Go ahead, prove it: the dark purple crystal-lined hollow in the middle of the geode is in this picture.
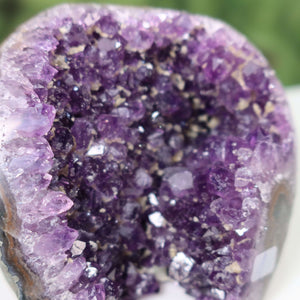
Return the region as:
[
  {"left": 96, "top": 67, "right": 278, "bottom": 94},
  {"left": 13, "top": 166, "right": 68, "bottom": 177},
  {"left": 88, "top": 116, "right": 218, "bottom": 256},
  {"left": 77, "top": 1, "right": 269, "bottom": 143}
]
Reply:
[{"left": 42, "top": 12, "right": 282, "bottom": 299}]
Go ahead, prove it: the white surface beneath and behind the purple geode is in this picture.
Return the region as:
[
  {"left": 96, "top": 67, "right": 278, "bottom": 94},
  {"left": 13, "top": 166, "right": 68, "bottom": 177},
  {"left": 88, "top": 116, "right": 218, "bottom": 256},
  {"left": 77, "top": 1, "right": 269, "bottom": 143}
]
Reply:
[{"left": 0, "top": 86, "right": 300, "bottom": 300}]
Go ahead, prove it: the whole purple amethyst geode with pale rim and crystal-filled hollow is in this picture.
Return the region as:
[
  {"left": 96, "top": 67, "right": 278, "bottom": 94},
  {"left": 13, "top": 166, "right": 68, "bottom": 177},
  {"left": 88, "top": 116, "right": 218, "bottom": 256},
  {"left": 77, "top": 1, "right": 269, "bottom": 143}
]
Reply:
[{"left": 0, "top": 5, "right": 295, "bottom": 300}]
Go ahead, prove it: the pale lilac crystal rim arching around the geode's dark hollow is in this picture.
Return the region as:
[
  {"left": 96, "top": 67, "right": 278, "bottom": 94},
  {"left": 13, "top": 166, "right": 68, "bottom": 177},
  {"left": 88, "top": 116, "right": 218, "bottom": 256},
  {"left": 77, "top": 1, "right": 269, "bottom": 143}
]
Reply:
[{"left": 0, "top": 5, "right": 295, "bottom": 300}]
